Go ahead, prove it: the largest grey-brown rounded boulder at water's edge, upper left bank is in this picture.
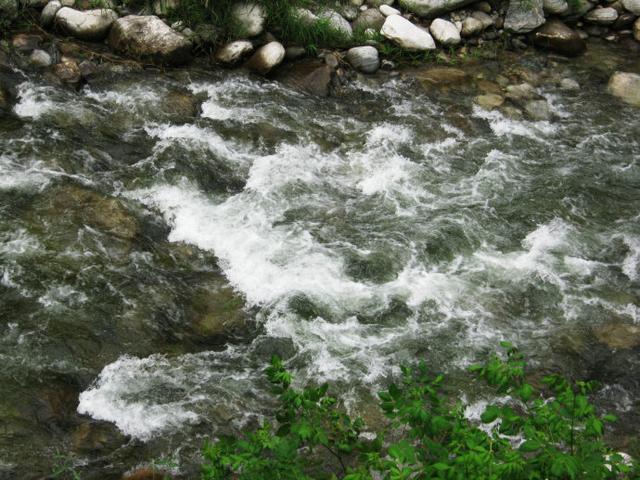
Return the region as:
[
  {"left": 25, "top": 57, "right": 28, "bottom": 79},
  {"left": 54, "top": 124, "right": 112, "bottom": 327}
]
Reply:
[{"left": 109, "top": 15, "right": 191, "bottom": 65}]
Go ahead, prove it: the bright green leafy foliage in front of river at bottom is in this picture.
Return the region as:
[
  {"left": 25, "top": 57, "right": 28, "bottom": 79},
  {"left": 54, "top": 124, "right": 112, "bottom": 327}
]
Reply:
[{"left": 202, "top": 342, "right": 639, "bottom": 480}]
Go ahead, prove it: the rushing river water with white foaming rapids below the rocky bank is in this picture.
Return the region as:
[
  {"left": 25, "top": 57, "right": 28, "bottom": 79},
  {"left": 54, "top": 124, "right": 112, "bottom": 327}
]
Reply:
[{"left": 0, "top": 43, "right": 640, "bottom": 479}]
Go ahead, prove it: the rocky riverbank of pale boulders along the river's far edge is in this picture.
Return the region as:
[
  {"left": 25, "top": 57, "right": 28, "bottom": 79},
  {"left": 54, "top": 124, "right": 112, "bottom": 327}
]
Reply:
[{"left": 0, "top": 0, "right": 640, "bottom": 107}]
